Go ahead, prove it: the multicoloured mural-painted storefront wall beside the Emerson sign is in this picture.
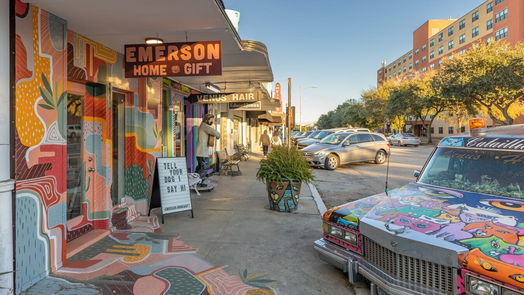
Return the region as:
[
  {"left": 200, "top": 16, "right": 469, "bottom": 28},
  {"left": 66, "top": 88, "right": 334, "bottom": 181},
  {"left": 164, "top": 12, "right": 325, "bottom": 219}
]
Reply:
[{"left": 15, "top": 1, "right": 162, "bottom": 291}]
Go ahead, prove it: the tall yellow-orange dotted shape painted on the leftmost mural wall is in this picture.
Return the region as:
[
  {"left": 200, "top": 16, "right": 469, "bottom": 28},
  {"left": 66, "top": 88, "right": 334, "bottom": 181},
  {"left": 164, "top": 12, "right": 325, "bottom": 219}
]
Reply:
[{"left": 15, "top": 6, "right": 49, "bottom": 147}]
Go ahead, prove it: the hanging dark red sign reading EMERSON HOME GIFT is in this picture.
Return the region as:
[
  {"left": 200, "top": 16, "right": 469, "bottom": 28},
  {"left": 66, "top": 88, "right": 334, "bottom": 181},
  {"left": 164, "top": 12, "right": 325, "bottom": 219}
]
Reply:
[{"left": 124, "top": 41, "right": 222, "bottom": 78}]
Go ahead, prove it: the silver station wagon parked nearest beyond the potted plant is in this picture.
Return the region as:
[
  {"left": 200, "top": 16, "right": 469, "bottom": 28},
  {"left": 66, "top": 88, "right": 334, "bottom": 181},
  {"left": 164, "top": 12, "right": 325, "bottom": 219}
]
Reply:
[{"left": 302, "top": 132, "right": 389, "bottom": 170}]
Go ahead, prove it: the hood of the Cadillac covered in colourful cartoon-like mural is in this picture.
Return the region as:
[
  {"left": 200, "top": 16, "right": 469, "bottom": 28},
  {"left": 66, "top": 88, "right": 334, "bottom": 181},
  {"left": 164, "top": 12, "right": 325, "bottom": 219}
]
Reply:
[{"left": 323, "top": 183, "right": 524, "bottom": 288}]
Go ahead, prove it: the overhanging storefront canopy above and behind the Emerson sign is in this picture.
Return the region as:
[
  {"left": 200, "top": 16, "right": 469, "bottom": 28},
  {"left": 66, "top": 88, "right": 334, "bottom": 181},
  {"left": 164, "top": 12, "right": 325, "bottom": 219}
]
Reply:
[{"left": 26, "top": 0, "right": 273, "bottom": 92}]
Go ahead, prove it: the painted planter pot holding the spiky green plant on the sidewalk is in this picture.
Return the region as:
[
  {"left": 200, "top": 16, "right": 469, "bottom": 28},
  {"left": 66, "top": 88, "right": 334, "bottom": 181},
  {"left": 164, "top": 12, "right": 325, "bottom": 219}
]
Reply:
[{"left": 267, "top": 180, "right": 302, "bottom": 212}]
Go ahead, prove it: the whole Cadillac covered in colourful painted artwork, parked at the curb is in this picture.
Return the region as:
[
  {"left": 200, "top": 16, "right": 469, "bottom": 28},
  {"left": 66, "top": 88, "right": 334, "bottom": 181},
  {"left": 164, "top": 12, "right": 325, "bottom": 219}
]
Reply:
[{"left": 314, "top": 125, "right": 524, "bottom": 295}]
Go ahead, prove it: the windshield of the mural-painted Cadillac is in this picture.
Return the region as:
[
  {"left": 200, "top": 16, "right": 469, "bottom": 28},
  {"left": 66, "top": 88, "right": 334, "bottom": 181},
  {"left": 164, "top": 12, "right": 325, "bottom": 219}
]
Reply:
[{"left": 419, "top": 148, "right": 524, "bottom": 199}]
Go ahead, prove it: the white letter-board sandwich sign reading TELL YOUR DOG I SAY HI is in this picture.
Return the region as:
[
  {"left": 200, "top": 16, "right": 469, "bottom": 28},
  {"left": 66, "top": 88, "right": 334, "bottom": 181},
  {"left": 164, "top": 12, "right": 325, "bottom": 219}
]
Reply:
[{"left": 149, "top": 157, "right": 194, "bottom": 223}]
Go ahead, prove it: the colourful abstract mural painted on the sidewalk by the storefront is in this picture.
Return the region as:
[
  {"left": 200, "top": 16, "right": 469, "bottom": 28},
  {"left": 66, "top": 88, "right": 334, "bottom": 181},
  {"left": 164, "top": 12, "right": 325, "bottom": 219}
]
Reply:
[{"left": 24, "top": 233, "right": 276, "bottom": 295}]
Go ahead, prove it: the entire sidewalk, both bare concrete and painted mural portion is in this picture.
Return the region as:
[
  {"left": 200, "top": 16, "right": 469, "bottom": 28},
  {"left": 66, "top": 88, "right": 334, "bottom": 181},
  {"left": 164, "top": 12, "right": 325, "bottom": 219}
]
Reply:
[{"left": 22, "top": 157, "right": 353, "bottom": 295}]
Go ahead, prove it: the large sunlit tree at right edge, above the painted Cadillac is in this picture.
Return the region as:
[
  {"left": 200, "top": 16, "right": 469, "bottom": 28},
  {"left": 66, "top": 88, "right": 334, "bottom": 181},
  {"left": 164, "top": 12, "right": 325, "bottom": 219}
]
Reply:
[{"left": 436, "top": 42, "right": 524, "bottom": 125}]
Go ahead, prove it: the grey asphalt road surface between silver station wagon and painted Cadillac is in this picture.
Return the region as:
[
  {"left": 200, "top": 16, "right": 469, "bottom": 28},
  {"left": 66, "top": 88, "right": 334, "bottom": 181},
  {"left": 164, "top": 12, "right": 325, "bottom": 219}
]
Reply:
[{"left": 314, "top": 145, "right": 434, "bottom": 208}]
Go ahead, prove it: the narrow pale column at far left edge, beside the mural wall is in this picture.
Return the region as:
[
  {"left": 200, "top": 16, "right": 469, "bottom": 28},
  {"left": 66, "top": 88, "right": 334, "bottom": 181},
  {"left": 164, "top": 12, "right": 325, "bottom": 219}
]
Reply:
[{"left": 0, "top": 1, "right": 14, "bottom": 295}]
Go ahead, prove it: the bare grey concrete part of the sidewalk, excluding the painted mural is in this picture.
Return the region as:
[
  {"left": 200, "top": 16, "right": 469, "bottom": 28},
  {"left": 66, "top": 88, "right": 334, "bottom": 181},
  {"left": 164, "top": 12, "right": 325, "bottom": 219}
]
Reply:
[{"left": 162, "top": 156, "right": 353, "bottom": 295}]
